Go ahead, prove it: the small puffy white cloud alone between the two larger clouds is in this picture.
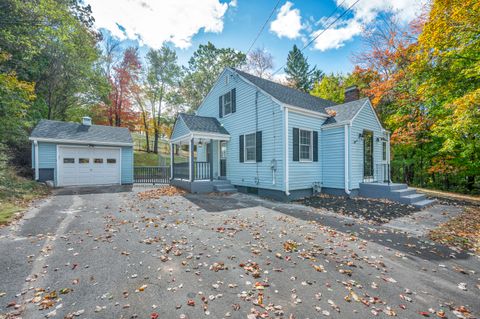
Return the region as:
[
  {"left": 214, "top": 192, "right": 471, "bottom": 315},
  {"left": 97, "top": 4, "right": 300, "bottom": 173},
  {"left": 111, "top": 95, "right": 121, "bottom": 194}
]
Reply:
[{"left": 270, "top": 1, "right": 302, "bottom": 39}]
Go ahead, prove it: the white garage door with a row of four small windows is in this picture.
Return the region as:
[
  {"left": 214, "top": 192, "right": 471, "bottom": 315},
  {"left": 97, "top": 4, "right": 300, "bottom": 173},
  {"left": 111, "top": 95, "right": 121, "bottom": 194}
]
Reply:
[{"left": 57, "top": 146, "right": 120, "bottom": 186}]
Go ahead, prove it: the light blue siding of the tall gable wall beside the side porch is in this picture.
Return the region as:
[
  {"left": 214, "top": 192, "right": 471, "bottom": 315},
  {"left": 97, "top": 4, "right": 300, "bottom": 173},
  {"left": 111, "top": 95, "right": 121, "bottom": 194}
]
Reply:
[{"left": 197, "top": 70, "right": 284, "bottom": 190}]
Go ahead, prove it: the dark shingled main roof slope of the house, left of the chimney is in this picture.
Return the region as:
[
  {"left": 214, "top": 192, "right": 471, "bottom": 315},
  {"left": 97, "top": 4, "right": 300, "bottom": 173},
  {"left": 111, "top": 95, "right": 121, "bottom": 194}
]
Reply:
[{"left": 233, "top": 69, "right": 336, "bottom": 115}]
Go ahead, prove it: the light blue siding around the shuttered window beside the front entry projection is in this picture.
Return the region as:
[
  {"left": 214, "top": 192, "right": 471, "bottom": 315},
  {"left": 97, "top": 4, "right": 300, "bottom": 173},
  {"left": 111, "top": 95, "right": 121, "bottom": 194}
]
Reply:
[{"left": 288, "top": 111, "right": 324, "bottom": 190}]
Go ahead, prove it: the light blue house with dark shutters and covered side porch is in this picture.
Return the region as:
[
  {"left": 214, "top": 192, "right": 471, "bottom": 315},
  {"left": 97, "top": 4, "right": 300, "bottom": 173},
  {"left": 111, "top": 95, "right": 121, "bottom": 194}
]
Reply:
[{"left": 171, "top": 68, "right": 436, "bottom": 208}]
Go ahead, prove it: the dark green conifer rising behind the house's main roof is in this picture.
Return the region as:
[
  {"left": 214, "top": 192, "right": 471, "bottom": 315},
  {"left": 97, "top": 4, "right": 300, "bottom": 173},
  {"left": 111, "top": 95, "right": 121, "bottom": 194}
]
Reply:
[{"left": 284, "top": 45, "right": 323, "bottom": 92}]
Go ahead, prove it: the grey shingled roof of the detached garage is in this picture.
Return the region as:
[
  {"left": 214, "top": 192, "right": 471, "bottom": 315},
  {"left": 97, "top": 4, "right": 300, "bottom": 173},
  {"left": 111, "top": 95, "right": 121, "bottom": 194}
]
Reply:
[{"left": 30, "top": 120, "right": 133, "bottom": 145}]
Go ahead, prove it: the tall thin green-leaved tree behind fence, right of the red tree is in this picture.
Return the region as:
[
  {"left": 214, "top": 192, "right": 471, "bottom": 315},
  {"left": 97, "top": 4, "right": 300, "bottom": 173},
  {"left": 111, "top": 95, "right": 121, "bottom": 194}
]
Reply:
[{"left": 145, "top": 44, "right": 182, "bottom": 153}]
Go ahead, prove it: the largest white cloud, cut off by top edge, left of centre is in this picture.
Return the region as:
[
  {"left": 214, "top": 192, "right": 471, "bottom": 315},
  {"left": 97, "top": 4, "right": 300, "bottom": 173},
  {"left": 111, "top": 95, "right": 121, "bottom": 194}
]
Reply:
[{"left": 86, "top": 0, "right": 232, "bottom": 48}]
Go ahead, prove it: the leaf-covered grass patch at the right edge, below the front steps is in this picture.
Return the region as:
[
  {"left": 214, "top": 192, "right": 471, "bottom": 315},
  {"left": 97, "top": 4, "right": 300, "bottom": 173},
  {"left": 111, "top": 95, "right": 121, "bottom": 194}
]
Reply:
[{"left": 429, "top": 206, "right": 480, "bottom": 255}]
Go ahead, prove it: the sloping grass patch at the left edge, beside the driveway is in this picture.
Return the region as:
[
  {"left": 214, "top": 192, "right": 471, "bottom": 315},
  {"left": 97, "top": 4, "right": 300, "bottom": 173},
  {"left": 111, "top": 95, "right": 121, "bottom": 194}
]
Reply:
[{"left": 0, "top": 168, "right": 49, "bottom": 225}]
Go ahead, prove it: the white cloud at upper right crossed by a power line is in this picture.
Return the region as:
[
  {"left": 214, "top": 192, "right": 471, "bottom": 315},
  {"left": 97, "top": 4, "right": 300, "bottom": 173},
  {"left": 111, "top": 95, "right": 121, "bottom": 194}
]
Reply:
[{"left": 310, "top": 0, "right": 427, "bottom": 51}]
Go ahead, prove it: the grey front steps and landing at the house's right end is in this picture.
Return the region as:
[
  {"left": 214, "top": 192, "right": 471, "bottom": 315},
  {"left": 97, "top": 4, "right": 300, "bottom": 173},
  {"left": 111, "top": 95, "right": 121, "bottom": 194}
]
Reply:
[{"left": 359, "top": 183, "right": 435, "bottom": 209}]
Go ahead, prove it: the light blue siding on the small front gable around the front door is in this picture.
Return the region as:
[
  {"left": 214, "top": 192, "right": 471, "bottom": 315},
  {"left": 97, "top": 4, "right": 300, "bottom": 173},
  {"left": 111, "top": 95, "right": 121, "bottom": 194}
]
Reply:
[{"left": 350, "top": 101, "right": 386, "bottom": 189}]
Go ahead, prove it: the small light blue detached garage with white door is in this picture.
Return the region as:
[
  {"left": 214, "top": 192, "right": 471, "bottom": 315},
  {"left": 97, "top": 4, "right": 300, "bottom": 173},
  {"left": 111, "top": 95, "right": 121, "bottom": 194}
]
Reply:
[{"left": 30, "top": 117, "right": 133, "bottom": 186}]
